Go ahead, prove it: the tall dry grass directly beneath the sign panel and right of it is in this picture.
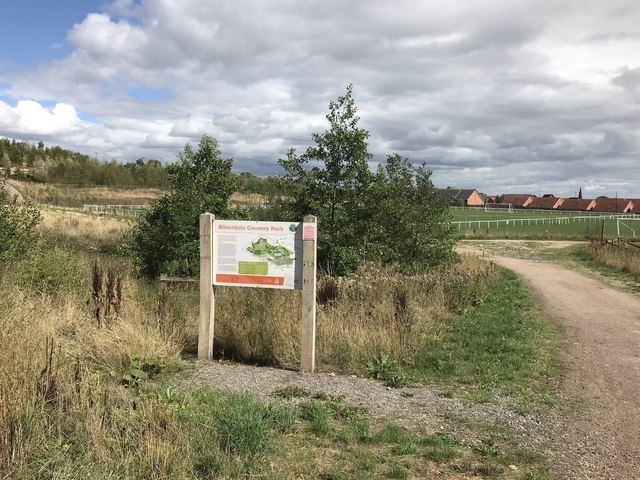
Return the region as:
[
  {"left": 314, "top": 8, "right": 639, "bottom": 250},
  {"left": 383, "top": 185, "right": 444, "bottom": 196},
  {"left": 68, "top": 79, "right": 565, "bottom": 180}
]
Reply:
[{"left": 209, "top": 255, "right": 496, "bottom": 372}]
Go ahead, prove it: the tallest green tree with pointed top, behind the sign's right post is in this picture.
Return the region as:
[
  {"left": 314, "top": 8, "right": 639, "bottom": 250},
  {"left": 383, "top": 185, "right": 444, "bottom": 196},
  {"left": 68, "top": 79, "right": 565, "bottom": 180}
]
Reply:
[{"left": 279, "top": 85, "right": 373, "bottom": 274}]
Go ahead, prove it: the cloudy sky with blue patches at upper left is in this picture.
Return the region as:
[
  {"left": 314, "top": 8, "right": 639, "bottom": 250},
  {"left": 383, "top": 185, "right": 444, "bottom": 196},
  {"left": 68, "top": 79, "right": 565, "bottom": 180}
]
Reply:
[{"left": 0, "top": 0, "right": 640, "bottom": 198}]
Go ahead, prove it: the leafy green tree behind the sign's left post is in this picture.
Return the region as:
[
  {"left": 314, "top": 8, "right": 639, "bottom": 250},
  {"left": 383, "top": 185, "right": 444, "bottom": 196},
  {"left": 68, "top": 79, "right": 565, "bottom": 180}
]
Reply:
[{"left": 132, "top": 135, "right": 235, "bottom": 278}]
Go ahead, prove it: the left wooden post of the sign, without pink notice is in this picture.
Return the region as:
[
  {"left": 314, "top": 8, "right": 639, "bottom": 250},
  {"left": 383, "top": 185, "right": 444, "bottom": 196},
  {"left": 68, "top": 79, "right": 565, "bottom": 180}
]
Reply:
[{"left": 198, "top": 213, "right": 215, "bottom": 360}]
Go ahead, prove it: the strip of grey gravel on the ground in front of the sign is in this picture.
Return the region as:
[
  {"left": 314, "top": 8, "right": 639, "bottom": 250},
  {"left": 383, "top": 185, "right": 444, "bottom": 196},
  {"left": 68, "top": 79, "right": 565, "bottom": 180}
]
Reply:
[{"left": 181, "top": 362, "right": 547, "bottom": 451}]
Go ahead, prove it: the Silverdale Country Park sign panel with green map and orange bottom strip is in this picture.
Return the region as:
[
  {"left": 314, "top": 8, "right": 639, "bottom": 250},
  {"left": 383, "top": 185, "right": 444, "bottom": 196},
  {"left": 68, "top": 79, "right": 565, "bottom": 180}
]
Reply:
[{"left": 213, "top": 220, "right": 302, "bottom": 289}]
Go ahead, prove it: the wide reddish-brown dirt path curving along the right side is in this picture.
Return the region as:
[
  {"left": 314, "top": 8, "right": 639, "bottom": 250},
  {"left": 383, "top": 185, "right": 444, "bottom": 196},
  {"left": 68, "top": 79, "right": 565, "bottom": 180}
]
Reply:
[{"left": 494, "top": 256, "right": 640, "bottom": 479}]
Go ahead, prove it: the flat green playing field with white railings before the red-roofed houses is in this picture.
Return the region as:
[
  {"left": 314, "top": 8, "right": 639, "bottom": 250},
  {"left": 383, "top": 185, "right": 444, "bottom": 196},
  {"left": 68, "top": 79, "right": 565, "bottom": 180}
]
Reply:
[{"left": 450, "top": 209, "right": 640, "bottom": 240}]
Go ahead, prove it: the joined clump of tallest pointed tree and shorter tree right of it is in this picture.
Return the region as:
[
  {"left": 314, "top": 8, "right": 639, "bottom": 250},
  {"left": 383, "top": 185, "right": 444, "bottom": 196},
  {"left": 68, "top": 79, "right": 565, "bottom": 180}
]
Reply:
[{"left": 279, "top": 86, "right": 453, "bottom": 275}]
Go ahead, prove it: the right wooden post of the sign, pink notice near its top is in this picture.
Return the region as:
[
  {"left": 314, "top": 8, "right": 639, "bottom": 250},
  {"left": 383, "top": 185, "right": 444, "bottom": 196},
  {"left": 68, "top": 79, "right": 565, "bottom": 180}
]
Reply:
[{"left": 300, "top": 215, "right": 318, "bottom": 372}]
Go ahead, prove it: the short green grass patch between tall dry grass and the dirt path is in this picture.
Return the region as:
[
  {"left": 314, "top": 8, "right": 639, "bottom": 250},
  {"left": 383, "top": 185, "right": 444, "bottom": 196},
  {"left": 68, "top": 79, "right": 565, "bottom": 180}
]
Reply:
[{"left": 416, "top": 270, "right": 557, "bottom": 412}]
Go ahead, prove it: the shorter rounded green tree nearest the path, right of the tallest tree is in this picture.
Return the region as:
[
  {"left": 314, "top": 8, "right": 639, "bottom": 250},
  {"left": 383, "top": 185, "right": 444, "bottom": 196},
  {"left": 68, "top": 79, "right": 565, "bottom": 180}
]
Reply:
[{"left": 370, "top": 154, "right": 454, "bottom": 273}]
